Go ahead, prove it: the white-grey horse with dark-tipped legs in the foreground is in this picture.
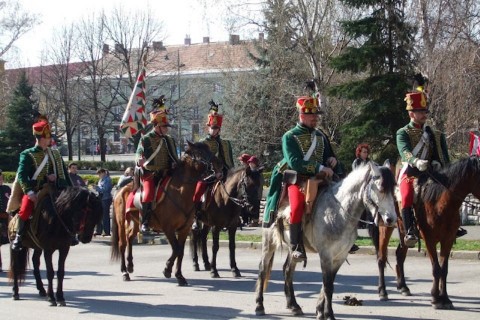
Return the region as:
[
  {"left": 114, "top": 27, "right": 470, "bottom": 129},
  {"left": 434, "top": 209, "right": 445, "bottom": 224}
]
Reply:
[{"left": 255, "top": 162, "right": 397, "bottom": 320}]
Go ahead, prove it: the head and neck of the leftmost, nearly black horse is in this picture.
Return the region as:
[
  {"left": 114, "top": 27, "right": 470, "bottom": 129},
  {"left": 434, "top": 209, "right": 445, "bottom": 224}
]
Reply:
[{"left": 55, "top": 187, "right": 102, "bottom": 243}]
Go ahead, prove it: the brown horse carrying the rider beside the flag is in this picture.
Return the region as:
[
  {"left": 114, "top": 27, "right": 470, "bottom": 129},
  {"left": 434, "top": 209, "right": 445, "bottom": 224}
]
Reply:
[{"left": 111, "top": 142, "right": 221, "bottom": 286}]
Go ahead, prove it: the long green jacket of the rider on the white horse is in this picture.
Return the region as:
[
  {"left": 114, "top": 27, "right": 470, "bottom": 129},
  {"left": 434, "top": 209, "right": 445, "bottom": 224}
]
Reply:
[{"left": 263, "top": 123, "right": 341, "bottom": 227}]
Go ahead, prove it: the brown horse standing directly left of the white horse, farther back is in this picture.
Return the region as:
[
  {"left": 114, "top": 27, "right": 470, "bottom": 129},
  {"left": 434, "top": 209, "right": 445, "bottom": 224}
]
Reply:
[{"left": 191, "top": 167, "right": 263, "bottom": 278}]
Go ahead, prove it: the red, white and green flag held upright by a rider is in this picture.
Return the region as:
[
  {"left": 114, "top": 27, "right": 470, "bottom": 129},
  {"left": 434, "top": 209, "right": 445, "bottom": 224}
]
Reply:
[{"left": 120, "top": 67, "right": 147, "bottom": 138}]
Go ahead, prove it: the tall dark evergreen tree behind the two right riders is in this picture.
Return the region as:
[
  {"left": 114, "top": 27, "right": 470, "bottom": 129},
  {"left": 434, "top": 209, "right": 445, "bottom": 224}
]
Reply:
[{"left": 329, "top": 0, "right": 415, "bottom": 165}]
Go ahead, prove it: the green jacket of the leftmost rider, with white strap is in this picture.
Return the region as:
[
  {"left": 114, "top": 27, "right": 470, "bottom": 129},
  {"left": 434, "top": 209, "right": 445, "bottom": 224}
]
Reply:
[{"left": 17, "top": 146, "right": 73, "bottom": 194}]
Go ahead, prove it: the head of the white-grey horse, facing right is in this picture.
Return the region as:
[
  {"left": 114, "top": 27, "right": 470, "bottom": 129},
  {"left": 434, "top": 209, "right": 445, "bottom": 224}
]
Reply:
[{"left": 362, "top": 162, "right": 397, "bottom": 226}]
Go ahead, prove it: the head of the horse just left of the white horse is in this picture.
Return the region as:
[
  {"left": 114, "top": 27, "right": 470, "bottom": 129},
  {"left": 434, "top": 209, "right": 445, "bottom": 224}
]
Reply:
[{"left": 237, "top": 167, "right": 263, "bottom": 216}]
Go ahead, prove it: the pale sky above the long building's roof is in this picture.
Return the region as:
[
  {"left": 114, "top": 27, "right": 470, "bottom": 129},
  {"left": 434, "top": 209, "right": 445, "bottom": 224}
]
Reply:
[{"left": 10, "top": 0, "right": 248, "bottom": 69}]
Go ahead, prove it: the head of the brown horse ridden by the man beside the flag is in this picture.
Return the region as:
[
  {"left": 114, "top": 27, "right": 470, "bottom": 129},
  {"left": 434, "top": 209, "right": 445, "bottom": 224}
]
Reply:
[{"left": 185, "top": 140, "right": 223, "bottom": 175}]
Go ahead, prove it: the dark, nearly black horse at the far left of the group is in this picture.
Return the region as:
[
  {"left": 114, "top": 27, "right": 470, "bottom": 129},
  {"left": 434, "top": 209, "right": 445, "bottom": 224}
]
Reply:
[{"left": 9, "top": 187, "right": 102, "bottom": 306}]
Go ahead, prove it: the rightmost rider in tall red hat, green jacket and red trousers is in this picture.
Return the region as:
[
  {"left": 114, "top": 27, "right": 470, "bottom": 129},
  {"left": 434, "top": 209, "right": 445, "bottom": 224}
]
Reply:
[{"left": 397, "top": 74, "right": 466, "bottom": 248}]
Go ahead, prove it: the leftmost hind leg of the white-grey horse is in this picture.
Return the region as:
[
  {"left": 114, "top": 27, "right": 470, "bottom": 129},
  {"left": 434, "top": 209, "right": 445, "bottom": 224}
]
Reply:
[{"left": 255, "top": 229, "right": 275, "bottom": 316}]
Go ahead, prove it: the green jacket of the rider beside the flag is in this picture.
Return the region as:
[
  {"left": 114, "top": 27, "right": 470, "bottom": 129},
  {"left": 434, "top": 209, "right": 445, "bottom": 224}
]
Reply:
[{"left": 136, "top": 130, "right": 178, "bottom": 171}]
